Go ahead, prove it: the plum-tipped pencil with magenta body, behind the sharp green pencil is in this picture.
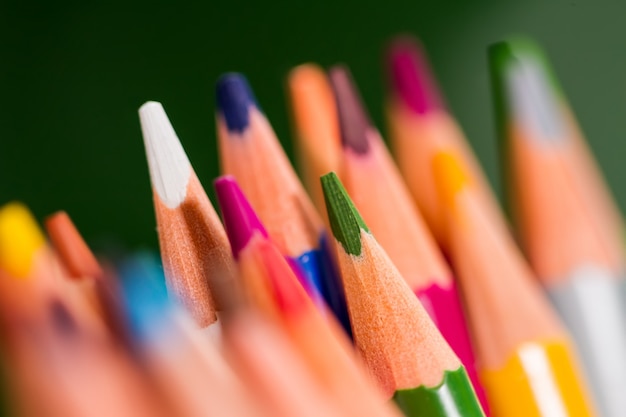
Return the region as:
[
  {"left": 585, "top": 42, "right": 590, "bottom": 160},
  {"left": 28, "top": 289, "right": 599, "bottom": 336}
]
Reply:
[{"left": 330, "top": 67, "right": 488, "bottom": 410}]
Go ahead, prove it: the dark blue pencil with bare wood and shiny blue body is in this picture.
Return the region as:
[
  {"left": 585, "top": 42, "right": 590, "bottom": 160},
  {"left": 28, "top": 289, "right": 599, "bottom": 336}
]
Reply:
[{"left": 216, "top": 74, "right": 350, "bottom": 333}]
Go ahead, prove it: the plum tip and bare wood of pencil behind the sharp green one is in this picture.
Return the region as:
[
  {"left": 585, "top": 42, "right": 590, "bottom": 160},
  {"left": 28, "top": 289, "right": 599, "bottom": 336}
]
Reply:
[{"left": 326, "top": 67, "right": 451, "bottom": 291}]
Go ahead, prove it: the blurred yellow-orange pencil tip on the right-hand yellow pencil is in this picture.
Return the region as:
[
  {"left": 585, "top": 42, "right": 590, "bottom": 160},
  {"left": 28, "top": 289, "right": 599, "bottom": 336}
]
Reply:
[{"left": 432, "top": 151, "right": 470, "bottom": 208}]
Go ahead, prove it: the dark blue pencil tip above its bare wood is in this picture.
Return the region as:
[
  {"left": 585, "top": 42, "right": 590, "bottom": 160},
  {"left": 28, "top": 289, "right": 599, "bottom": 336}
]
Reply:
[{"left": 215, "top": 72, "right": 257, "bottom": 134}]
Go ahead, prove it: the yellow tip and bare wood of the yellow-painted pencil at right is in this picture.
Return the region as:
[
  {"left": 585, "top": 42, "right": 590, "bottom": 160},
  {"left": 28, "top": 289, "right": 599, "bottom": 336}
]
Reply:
[{"left": 433, "top": 152, "right": 565, "bottom": 368}]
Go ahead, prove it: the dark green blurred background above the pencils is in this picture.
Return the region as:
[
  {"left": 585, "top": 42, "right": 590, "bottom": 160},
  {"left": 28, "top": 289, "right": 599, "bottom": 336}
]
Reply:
[{"left": 0, "top": 0, "right": 626, "bottom": 249}]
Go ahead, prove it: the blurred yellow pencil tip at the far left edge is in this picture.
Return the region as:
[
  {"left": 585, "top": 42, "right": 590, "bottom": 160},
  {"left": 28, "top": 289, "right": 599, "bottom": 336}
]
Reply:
[{"left": 0, "top": 202, "right": 46, "bottom": 278}]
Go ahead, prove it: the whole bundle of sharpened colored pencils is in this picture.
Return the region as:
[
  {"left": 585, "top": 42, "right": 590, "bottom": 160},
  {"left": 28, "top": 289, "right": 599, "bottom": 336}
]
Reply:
[{"left": 0, "top": 30, "right": 626, "bottom": 417}]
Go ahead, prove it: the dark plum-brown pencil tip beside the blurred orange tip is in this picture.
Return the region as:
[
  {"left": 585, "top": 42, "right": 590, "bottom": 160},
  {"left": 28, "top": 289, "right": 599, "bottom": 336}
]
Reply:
[{"left": 328, "top": 66, "right": 371, "bottom": 154}]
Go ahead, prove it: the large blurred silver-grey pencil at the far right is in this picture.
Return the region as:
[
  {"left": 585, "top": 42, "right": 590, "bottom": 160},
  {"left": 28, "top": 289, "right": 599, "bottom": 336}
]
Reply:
[{"left": 489, "top": 35, "right": 626, "bottom": 417}]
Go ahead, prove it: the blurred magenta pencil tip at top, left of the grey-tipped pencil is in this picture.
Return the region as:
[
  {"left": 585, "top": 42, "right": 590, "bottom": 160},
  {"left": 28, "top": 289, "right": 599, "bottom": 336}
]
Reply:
[{"left": 388, "top": 37, "right": 444, "bottom": 114}]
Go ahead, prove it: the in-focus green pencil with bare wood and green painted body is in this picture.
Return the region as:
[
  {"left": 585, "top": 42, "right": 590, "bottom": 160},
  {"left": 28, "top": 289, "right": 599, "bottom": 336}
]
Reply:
[{"left": 322, "top": 173, "right": 484, "bottom": 417}]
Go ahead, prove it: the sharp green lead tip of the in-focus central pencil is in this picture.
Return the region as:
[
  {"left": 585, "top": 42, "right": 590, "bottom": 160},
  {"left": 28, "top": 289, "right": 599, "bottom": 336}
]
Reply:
[{"left": 321, "top": 172, "right": 369, "bottom": 256}]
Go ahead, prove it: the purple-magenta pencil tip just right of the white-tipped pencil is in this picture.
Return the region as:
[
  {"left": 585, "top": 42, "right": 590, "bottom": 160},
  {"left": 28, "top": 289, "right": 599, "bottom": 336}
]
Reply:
[{"left": 213, "top": 175, "right": 267, "bottom": 258}]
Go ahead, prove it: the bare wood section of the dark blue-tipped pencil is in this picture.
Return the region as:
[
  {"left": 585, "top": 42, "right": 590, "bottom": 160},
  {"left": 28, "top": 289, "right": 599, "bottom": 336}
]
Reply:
[{"left": 217, "top": 75, "right": 324, "bottom": 257}]
